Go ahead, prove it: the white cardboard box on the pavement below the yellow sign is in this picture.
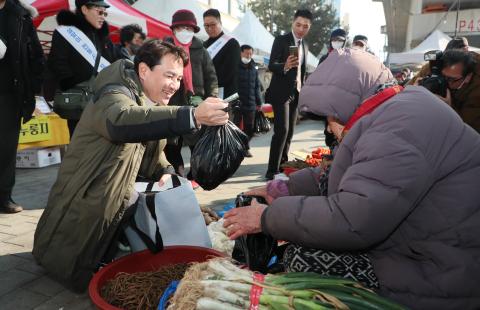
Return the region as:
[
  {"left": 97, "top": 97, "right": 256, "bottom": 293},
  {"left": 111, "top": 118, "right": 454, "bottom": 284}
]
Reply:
[{"left": 16, "top": 147, "right": 61, "bottom": 168}]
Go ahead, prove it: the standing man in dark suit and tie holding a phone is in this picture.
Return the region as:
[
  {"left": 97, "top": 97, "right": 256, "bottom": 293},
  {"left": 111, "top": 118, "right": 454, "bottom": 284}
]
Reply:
[{"left": 265, "top": 10, "right": 313, "bottom": 180}]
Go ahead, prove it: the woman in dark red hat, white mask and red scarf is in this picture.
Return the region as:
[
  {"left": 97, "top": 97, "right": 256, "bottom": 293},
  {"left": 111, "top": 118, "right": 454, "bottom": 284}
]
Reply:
[{"left": 165, "top": 10, "right": 218, "bottom": 189}]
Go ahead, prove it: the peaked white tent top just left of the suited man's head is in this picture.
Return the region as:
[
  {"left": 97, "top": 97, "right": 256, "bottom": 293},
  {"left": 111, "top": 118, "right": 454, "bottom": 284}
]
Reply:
[{"left": 232, "top": 10, "right": 318, "bottom": 68}]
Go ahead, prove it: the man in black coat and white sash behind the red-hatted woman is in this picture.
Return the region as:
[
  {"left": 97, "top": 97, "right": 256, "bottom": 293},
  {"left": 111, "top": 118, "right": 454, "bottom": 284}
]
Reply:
[{"left": 203, "top": 9, "right": 240, "bottom": 98}]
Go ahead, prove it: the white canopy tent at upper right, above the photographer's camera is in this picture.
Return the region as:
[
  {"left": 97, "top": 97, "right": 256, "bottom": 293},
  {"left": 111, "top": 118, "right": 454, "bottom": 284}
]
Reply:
[{"left": 388, "top": 30, "right": 480, "bottom": 65}]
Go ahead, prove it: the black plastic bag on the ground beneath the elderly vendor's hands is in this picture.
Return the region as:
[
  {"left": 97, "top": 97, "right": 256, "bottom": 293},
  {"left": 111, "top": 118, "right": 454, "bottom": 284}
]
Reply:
[{"left": 232, "top": 194, "right": 277, "bottom": 273}]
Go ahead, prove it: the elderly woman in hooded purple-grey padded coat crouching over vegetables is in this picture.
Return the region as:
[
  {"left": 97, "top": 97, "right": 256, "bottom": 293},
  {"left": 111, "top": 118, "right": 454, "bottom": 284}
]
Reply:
[{"left": 225, "top": 49, "right": 480, "bottom": 309}]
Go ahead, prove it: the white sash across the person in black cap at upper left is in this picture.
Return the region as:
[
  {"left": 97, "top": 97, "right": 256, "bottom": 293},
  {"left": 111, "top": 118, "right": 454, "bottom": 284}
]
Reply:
[{"left": 56, "top": 26, "right": 110, "bottom": 72}]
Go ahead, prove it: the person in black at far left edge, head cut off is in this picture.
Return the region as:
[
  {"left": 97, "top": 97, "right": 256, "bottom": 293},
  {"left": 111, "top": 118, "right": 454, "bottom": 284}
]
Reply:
[{"left": 0, "top": 0, "right": 44, "bottom": 213}]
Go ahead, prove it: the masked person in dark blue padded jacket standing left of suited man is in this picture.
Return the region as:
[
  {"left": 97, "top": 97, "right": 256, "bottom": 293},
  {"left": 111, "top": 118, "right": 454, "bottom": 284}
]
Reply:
[{"left": 233, "top": 45, "right": 262, "bottom": 157}]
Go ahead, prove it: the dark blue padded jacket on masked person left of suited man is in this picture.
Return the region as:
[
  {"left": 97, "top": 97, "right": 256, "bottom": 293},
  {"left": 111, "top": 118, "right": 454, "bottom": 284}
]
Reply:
[{"left": 238, "top": 60, "right": 262, "bottom": 111}]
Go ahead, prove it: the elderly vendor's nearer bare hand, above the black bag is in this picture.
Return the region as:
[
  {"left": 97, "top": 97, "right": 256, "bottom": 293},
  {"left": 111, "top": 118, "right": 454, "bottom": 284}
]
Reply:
[{"left": 223, "top": 199, "right": 268, "bottom": 240}]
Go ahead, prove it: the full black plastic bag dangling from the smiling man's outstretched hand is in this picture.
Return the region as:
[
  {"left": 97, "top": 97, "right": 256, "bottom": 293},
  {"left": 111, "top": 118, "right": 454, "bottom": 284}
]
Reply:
[{"left": 190, "top": 121, "right": 248, "bottom": 190}]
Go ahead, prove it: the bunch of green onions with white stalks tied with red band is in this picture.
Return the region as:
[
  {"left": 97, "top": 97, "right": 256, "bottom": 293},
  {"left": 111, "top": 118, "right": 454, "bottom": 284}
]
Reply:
[{"left": 168, "top": 258, "right": 406, "bottom": 310}]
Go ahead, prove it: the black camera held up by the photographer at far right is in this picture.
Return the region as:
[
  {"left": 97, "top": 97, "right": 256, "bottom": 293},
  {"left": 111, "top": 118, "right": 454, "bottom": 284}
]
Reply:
[{"left": 418, "top": 50, "right": 447, "bottom": 97}]
